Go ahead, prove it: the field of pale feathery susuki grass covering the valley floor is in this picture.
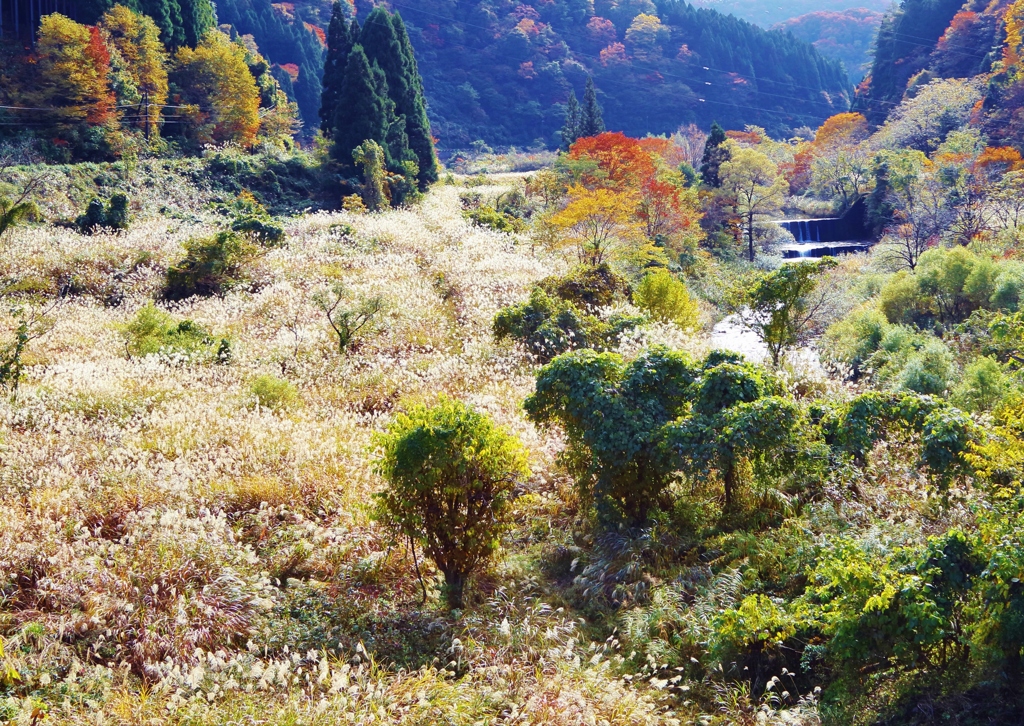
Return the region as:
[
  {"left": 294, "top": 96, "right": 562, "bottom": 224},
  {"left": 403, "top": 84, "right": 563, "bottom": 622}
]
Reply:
[{"left": 0, "top": 179, "right": 724, "bottom": 724}]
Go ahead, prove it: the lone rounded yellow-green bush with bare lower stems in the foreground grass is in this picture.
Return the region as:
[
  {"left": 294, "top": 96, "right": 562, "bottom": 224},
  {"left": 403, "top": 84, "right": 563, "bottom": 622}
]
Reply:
[{"left": 375, "top": 398, "right": 529, "bottom": 608}]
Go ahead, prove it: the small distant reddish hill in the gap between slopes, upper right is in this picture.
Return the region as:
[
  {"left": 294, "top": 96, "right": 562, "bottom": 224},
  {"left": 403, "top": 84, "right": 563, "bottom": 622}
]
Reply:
[{"left": 772, "top": 7, "right": 883, "bottom": 83}]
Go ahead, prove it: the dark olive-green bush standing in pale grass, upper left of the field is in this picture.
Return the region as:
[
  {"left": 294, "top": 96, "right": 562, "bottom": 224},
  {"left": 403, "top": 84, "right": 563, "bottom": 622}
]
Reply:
[{"left": 164, "top": 231, "right": 258, "bottom": 300}]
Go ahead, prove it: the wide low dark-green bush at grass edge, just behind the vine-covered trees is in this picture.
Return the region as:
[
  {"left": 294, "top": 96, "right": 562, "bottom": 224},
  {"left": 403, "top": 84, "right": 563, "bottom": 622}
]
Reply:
[{"left": 492, "top": 287, "right": 643, "bottom": 361}]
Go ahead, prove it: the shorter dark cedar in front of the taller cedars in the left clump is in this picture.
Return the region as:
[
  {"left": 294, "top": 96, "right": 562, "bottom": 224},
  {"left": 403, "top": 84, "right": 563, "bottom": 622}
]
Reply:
[{"left": 332, "top": 45, "right": 388, "bottom": 170}]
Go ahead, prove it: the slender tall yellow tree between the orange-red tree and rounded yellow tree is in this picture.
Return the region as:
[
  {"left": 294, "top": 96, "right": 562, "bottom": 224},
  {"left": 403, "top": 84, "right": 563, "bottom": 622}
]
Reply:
[{"left": 100, "top": 5, "right": 167, "bottom": 133}]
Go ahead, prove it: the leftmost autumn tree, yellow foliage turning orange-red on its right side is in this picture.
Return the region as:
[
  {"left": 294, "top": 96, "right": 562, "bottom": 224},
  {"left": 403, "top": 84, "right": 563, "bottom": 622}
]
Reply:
[{"left": 34, "top": 13, "right": 115, "bottom": 126}]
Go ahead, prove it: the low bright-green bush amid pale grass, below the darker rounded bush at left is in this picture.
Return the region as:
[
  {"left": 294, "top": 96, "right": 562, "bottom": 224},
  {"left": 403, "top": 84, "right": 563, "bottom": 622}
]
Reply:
[{"left": 121, "top": 303, "right": 231, "bottom": 362}]
